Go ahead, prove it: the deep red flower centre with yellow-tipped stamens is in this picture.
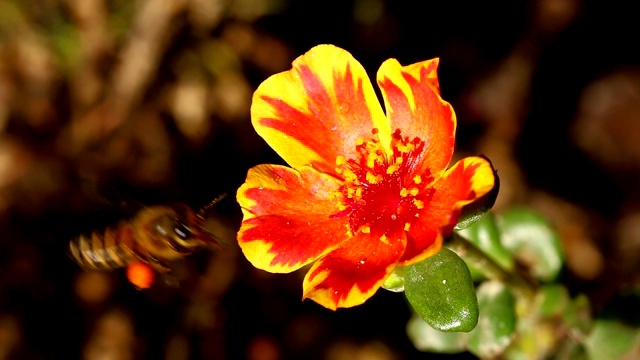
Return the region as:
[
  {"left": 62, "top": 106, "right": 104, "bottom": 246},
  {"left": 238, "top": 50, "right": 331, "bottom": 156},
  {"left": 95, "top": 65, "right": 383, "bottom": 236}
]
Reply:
[{"left": 333, "top": 128, "right": 434, "bottom": 241}]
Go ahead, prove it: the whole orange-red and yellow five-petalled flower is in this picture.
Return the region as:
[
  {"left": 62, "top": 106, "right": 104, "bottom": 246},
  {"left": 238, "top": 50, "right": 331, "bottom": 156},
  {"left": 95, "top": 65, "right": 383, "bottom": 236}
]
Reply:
[{"left": 237, "top": 45, "right": 494, "bottom": 310}]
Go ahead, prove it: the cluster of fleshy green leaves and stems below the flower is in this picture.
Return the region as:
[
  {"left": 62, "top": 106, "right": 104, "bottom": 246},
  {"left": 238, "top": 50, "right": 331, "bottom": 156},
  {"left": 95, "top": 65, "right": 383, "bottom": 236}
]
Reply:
[{"left": 404, "top": 208, "right": 640, "bottom": 360}]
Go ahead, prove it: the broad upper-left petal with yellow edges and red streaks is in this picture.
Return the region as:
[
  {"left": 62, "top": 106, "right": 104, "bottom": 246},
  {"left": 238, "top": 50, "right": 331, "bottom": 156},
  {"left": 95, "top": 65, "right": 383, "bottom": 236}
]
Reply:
[{"left": 251, "top": 45, "right": 389, "bottom": 173}]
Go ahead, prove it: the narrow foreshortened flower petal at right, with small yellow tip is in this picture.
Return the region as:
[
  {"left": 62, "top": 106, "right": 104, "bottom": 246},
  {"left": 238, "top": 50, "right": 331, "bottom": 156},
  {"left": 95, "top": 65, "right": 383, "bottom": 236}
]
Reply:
[{"left": 400, "top": 156, "right": 495, "bottom": 265}]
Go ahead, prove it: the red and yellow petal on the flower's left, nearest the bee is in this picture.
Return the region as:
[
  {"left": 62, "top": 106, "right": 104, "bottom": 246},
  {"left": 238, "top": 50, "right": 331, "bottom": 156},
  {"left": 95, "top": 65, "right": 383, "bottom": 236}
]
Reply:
[{"left": 237, "top": 165, "right": 347, "bottom": 273}]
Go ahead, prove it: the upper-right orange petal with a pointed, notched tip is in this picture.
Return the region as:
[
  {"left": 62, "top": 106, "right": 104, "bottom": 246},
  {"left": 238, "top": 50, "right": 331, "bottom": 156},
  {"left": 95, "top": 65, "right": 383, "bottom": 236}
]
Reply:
[{"left": 377, "top": 58, "right": 456, "bottom": 178}]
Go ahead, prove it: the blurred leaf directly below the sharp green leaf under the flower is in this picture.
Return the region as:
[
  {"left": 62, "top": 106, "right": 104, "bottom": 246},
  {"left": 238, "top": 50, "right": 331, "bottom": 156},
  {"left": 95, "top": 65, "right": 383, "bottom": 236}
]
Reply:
[{"left": 407, "top": 313, "right": 468, "bottom": 354}]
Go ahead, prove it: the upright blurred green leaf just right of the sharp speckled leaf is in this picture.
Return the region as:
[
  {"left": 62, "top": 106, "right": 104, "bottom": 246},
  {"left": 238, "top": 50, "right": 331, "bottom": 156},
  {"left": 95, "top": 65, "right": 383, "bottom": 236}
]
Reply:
[{"left": 468, "top": 281, "right": 516, "bottom": 359}]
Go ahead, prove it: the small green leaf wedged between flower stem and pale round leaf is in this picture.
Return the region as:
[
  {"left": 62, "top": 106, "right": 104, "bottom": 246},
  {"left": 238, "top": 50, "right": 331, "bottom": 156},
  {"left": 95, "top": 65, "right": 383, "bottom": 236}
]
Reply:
[{"left": 458, "top": 213, "right": 514, "bottom": 271}]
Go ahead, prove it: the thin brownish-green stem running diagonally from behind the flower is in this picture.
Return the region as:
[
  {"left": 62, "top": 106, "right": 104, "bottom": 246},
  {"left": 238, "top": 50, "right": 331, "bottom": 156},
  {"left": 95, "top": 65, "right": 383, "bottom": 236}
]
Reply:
[{"left": 446, "top": 231, "right": 535, "bottom": 300}]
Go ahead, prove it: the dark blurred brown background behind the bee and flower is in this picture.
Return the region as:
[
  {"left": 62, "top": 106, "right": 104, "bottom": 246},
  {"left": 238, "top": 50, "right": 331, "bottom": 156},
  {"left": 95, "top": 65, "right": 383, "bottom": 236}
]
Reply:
[{"left": 0, "top": 0, "right": 640, "bottom": 360}]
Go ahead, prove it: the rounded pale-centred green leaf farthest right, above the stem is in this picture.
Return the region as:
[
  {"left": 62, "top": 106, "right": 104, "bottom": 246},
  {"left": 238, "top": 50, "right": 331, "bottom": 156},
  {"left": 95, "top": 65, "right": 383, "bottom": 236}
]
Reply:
[{"left": 496, "top": 208, "right": 564, "bottom": 281}]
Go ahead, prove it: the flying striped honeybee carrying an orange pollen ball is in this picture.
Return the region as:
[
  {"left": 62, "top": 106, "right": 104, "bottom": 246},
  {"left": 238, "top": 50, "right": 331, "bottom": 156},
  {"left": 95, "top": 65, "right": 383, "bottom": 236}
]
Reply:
[{"left": 68, "top": 195, "right": 224, "bottom": 273}]
